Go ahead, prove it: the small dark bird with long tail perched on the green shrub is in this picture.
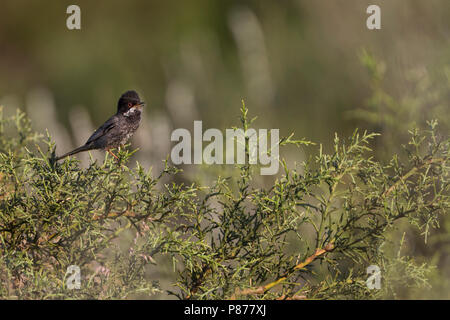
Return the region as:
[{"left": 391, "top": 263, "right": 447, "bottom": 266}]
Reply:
[{"left": 56, "top": 90, "right": 144, "bottom": 161}]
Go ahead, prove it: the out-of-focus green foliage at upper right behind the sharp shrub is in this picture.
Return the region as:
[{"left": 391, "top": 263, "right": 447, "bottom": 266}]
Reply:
[{"left": 350, "top": 50, "right": 450, "bottom": 157}]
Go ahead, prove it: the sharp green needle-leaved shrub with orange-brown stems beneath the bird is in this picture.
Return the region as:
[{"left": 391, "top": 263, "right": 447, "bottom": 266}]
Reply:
[{"left": 0, "top": 106, "right": 449, "bottom": 299}]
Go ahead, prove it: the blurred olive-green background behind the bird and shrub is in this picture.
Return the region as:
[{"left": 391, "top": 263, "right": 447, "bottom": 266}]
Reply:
[{"left": 0, "top": 0, "right": 450, "bottom": 298}]
